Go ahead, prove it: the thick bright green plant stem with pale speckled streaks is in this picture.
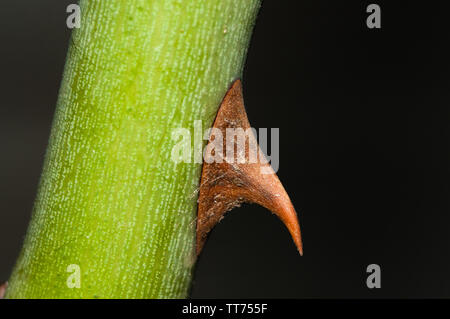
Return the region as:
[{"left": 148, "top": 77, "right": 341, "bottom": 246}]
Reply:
[{"left": 6, "top": 0, "right": 260, "bottom": 298}]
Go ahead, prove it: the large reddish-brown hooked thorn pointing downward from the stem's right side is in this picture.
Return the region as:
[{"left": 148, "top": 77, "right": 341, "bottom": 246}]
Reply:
[{"left": 197, "top": 79, "right": 303, "bottom": 255}]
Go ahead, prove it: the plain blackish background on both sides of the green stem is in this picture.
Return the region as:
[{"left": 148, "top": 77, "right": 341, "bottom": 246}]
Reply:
[{"left": 0, "top": 0, "right": 450, "bottom": 298}]
